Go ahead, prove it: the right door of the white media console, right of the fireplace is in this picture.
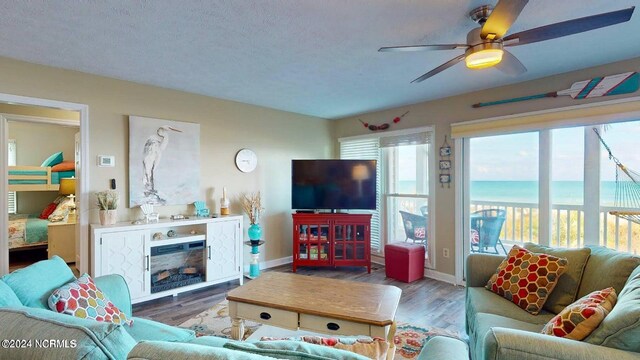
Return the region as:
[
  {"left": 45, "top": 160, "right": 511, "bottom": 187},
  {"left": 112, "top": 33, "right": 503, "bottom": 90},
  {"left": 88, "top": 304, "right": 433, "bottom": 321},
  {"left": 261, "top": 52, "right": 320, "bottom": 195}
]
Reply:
[{"left": 207, "top": 220, "right": 241, "bottom": 281}]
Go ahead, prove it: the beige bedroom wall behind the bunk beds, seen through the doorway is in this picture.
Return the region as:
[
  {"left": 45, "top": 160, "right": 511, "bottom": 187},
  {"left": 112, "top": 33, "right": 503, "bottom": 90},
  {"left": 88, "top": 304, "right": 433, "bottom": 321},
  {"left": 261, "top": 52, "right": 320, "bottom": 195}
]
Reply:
[{"left": 9, "top": 121, "right": 78, "bottom": 214}]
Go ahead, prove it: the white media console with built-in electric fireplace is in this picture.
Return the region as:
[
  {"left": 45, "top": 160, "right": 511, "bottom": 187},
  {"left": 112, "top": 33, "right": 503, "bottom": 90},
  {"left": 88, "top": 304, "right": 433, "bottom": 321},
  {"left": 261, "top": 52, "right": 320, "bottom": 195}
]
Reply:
[{"left": 91, "top": 215, "right": 243, "bottom": 303}]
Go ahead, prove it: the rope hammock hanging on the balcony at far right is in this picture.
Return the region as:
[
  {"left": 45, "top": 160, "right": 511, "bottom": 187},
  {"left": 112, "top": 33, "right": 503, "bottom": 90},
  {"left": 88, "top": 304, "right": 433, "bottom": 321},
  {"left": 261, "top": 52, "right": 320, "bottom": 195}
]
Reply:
[{"left": 593, "top": 128, "right": 640, "bottom": 224}]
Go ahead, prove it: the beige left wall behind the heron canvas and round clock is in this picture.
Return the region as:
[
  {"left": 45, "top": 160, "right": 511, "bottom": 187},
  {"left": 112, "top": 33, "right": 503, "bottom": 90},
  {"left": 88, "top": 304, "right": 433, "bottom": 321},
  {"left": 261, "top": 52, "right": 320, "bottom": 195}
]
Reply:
[{"left": 0, "top": 58, "right": 333, "bottom": 260}]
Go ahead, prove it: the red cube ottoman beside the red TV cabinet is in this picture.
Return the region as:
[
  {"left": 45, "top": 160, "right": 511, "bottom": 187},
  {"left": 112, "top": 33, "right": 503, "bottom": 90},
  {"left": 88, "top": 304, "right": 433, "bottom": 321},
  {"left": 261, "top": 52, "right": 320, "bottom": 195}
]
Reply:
[{"left": 384, "top": 242, "right": 424, "bottom": 282}]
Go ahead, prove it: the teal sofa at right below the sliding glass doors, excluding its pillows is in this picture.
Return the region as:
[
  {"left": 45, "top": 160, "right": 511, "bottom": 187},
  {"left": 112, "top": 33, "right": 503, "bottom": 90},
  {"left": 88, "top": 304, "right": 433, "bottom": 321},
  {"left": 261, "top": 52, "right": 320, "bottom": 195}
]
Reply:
[{"left": 465, "top": 243, "right": 640, "bottom": 360}]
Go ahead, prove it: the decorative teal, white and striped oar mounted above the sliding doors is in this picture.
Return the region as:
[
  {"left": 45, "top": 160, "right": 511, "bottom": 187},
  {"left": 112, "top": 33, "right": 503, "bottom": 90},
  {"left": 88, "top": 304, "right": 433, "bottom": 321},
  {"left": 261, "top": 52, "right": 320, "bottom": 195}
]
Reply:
[{"left": 472, "top": 71, "right": 640, "bottom": 108}]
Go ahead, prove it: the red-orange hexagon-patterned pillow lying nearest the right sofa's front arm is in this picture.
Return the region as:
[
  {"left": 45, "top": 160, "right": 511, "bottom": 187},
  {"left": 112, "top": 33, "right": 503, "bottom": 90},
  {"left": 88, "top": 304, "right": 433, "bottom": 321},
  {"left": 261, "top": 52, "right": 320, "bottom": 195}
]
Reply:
[{"left": 542, "top": 288, "right": 617, "bottom": 340}]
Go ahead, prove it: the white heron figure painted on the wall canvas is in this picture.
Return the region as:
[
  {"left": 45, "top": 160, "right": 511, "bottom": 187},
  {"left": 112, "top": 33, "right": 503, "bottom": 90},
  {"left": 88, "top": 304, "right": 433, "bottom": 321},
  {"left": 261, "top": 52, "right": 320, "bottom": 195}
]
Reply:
[{"left": 142, "top": 125, "right": 182, "bottom": 205}]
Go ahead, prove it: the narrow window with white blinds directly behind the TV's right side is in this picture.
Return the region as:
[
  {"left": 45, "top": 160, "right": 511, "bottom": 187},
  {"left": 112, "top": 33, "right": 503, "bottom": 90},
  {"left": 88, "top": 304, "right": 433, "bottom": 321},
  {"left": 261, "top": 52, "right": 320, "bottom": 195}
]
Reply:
[{"left": 340, "top": 138, "right": 381, "bottom": 252}]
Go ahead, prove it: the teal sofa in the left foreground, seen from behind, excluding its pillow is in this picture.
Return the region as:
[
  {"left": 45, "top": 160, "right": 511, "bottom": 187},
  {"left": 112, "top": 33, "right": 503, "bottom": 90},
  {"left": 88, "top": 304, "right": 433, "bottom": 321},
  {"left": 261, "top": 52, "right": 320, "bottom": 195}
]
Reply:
[{"left": 0, "top": 256, "right": 467, "bottom": 360}]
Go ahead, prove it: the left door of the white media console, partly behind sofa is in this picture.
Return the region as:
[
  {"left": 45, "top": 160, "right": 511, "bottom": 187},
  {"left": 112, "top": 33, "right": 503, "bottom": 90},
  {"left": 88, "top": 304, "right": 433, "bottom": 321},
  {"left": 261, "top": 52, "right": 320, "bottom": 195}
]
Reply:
[{"left": 99, "top": 230, "right": 151, "bottom": 300}]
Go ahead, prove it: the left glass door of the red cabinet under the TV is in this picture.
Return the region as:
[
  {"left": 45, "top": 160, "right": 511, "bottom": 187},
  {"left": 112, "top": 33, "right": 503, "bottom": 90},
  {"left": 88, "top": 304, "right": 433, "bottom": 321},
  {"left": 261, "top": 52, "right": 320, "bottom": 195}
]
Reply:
[{"left": 297, "top": 224, "right": 330, "bottom": 263}]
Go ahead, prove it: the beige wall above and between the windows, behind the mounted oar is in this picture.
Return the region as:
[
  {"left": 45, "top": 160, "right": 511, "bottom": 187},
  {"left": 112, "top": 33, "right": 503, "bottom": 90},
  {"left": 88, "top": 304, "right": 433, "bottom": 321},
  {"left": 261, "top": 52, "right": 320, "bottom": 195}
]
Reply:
[{"left": 333, "top": 58, "right": 640, "bottom": 275}]
